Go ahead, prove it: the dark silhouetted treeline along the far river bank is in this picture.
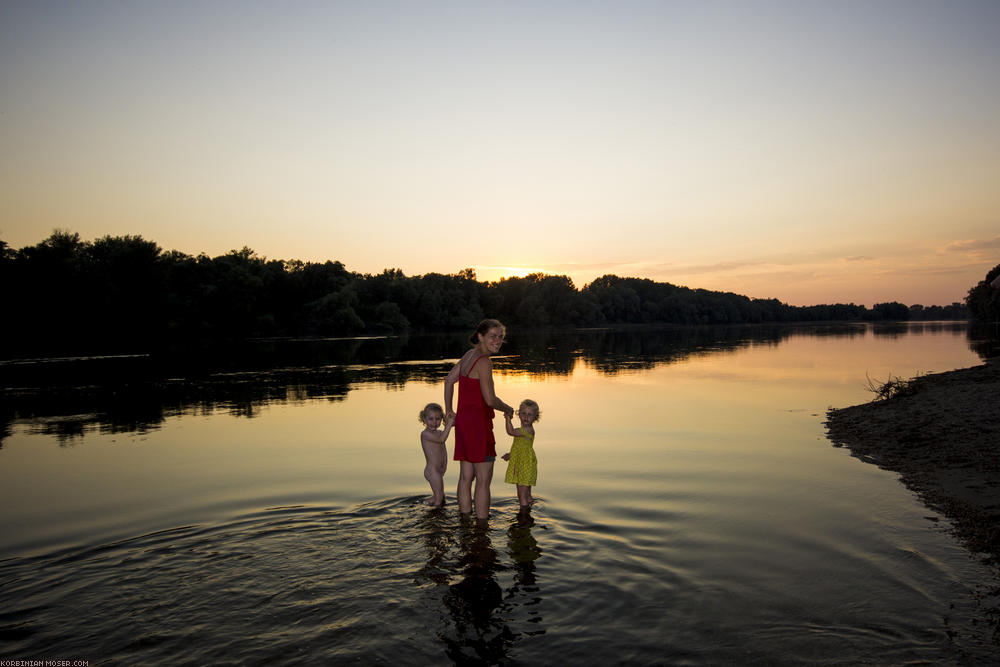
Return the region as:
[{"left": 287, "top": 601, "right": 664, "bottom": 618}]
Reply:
[{"left": 0, "top": 230, "right": 984, "bottom": 352}]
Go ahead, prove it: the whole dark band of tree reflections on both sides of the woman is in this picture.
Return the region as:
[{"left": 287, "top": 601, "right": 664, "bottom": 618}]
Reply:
[{"left": 0, "top": 323, "right": 984, "bottom": 443}]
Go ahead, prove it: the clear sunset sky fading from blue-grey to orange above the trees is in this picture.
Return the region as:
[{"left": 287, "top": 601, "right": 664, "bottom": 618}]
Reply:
[{"left": 0, "top": 0, "right": 1000, "bottom": 306}]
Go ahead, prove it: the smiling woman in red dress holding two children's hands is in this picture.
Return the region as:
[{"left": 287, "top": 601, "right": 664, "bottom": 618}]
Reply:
[{"left": 444, "top": 320, "right": 514, "bottom": 519}]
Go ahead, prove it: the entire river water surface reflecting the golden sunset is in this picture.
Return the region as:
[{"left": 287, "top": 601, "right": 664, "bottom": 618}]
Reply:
[{"left": 0, "top": 324, "right": 997, "bottom": 664}]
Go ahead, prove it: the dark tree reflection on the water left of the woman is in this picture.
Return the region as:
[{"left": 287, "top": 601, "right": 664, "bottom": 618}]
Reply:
[{"left": 0, "top": 335, "right": 464, "bottom": 444}]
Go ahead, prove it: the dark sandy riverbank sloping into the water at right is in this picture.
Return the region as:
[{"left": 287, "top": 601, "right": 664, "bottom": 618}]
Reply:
[{"left": 827, "top": 359, "right": 1000, "bottom": 565}]
